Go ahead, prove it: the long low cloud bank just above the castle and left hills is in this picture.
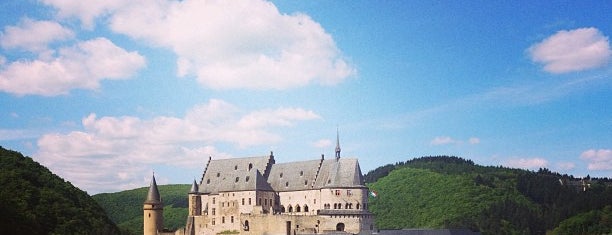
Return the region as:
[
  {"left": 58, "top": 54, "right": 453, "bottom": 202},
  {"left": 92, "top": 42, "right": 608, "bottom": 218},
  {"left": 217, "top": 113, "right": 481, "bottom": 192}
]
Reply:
[{"left": 35, "top": 100, "right": 320, "bottom": 192}]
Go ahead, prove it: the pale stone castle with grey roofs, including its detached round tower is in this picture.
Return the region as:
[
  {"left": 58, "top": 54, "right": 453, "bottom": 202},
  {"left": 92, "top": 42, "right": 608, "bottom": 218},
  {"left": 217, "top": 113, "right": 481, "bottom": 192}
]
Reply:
[{"left": 143, "top": 134, "right": 374, "bottom": 235}]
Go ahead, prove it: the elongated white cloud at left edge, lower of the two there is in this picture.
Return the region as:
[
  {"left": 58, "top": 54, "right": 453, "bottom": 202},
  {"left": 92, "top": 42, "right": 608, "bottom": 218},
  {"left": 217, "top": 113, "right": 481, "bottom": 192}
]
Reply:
[{"left": 0, "top": 38, "right": 145, "bottom": 96}]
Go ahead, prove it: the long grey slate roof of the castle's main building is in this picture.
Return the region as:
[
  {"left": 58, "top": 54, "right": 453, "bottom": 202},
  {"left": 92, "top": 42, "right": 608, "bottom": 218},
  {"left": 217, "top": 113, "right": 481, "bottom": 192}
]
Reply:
[{"left": 199, "top": 155, "right": 365, "bottom": 194}]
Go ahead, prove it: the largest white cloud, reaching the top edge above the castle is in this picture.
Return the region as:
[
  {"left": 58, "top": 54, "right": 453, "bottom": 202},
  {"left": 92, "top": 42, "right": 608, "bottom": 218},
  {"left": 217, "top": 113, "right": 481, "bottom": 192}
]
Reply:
[{"left": 45, "top": 0, "right": 355, "bottom": 89}]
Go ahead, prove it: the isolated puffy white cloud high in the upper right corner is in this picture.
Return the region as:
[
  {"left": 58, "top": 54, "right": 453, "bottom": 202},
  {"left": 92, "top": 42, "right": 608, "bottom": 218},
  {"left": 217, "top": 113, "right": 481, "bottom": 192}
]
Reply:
[{"left": 527, "top": 28, "right": 612, "bottom": 73}]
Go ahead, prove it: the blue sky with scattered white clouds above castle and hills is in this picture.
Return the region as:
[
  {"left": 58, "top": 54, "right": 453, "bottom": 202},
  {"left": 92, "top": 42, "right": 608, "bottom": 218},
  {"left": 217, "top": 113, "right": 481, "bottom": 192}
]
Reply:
[{"left": 0, "top": 0, "right": 612, "bottom": 194}]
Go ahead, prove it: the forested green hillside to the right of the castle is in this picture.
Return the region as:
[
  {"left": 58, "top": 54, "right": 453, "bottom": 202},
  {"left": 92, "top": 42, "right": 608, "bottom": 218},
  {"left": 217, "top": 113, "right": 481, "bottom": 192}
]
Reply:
[{"left": 365, "top": 156, "right": 612, "bottom": 234}]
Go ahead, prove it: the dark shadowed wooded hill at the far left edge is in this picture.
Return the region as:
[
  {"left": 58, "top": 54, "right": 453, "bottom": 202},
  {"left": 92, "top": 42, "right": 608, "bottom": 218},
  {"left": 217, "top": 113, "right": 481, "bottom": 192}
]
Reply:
[{"left": 0, "top": 147, "right": 120, "bottom": 234}]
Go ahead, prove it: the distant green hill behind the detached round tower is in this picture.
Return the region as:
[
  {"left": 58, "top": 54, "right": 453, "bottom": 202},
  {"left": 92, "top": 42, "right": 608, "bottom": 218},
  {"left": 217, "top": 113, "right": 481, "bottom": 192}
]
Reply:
[{"left": 93, "top": 184, "right": 191, "bottom": 234}]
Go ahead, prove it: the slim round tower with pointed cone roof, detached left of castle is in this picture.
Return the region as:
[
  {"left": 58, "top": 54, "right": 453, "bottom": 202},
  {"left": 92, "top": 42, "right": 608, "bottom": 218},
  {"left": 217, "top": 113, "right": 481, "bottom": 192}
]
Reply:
[{"left": 142, "top": 174, "right": 164, "bottom": 235}]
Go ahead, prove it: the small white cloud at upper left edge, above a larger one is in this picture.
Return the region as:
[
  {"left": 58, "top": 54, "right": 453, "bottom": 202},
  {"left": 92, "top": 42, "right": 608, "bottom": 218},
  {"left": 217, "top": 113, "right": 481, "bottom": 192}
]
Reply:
[{"left": 0, "top": 18, "right": 74, "bottom": 52}]
